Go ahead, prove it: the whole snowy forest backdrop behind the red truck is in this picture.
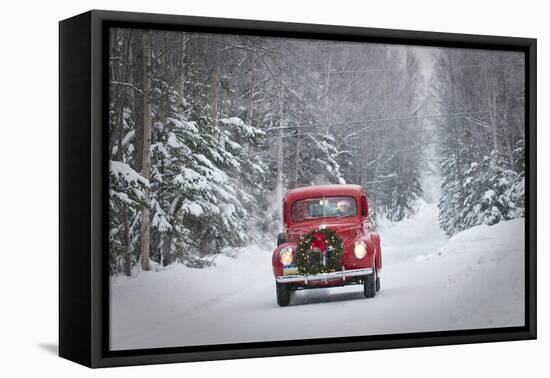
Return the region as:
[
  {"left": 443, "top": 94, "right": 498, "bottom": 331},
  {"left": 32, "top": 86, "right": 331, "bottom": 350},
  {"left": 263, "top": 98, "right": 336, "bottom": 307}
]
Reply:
[{"left": 108, "top": 28, "right": 525, "bottom": 275}]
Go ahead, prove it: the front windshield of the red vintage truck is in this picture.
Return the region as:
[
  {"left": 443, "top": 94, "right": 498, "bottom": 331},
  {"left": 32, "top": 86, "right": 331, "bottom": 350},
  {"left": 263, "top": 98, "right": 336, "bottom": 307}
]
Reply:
[{"left": 291, "top": 197, "right": 357, "bottom": 222}]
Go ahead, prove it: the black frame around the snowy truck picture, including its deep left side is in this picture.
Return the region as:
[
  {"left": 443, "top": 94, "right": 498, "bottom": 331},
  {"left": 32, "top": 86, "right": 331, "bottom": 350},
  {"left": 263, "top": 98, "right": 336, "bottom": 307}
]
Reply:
[{"left": 59, "top": 10, "right": 537, "bottom": 367}]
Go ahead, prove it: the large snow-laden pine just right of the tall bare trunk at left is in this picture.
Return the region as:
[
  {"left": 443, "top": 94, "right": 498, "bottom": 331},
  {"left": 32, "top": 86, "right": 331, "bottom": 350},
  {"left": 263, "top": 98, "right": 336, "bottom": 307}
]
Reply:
[{"left": 151, "top": 89, "right": 256, "bottom": 266}]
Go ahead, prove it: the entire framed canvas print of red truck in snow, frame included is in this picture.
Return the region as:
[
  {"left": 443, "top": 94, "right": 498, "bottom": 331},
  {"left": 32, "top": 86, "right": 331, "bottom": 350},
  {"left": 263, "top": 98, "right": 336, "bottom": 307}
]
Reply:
[{"left": 59, "top": 11, "right": 536, "bottom": 367}]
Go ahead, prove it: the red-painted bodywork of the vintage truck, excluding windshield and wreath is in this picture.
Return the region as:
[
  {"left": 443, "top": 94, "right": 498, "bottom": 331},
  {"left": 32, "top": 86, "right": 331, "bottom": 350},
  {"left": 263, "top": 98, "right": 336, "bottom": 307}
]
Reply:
[{"left": 272, "top": 185, "right": 382, "bottom": 286}]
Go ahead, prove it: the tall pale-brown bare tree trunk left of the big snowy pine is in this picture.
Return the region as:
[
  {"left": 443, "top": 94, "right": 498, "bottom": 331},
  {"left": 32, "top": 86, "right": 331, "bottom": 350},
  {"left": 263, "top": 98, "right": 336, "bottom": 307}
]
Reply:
[{"left": 140, "top": 31, "right": 153, "bottom": 270}]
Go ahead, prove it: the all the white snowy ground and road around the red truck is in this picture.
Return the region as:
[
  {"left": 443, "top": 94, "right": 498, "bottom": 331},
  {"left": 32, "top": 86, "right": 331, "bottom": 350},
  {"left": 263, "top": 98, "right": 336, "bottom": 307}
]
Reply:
[{"left": 111, "top": 203, "right": 524, "bottom": 350}]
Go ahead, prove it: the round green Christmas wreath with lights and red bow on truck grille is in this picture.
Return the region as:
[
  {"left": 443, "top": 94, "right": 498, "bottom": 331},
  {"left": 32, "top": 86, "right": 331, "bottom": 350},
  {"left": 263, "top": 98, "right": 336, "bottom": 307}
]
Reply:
[{"left": 296, "top": 228, "right": 343, "bottom": 274}]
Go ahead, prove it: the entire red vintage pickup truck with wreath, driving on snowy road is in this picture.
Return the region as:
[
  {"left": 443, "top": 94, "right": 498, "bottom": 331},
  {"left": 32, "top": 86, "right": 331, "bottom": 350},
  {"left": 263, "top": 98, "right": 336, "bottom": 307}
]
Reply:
[{"left": 272, "top": 185, "right": 382, "bottom": 306}]
